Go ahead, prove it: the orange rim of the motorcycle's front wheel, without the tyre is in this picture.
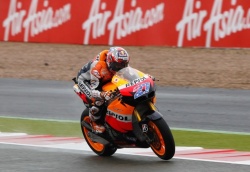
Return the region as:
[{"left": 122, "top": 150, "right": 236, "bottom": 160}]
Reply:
[{"left": 148, "top": 121, "right": 166, "bottom": 155}]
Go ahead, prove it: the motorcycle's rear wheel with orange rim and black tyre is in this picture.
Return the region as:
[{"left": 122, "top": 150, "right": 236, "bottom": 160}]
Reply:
[{"left": 80, "top": 109, "right": 117, "bottom": 156}]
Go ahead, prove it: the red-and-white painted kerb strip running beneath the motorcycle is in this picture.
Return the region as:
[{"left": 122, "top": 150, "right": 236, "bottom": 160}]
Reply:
[{"left": 0, "top": 132, "right": 250, "bottom": 165}]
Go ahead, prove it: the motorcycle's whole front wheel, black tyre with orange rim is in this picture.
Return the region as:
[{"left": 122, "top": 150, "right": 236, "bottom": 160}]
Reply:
[{"left": 148, "top": 118, "right": 175, "bottom": 160}]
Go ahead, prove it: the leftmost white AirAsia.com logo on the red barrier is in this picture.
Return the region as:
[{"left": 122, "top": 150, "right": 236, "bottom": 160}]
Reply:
[{"left": 3, "top": 0, "right": 71, "bottom": 42}]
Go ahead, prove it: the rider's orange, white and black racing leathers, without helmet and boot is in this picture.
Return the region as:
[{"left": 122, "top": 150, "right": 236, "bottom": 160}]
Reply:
[{"left": 74, "top": 50, "right": 113, "bottom": 121}]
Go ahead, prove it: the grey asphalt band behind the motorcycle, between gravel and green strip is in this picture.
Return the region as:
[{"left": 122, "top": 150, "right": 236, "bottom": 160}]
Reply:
[{"left": 0, "top": 79, "right": 250, "bottom": 133}]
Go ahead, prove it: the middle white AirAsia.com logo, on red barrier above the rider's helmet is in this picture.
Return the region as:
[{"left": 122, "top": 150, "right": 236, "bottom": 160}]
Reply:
[{"left": 82, "top": 0, "right": 165, "bottom": 45}]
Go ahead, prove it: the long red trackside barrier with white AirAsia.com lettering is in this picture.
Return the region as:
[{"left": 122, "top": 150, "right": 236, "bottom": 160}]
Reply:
[{"left": 0, "top": 0, "right": 250, "bottom": 48}]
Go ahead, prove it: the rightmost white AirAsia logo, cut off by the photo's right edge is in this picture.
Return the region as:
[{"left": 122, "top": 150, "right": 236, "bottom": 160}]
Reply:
[{"left": 176, "top": 0, "right": 250, "bottom": 47}]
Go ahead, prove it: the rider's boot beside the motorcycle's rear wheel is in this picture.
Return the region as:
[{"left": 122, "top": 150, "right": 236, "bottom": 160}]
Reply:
[{"left": 89, "top": 106, "right": 105, "bottom": 133}]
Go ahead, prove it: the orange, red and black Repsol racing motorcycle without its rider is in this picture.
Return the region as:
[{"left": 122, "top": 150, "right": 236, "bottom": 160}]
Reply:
[{"left": 72, "top": 66, "right": 175, "bottom": 160}]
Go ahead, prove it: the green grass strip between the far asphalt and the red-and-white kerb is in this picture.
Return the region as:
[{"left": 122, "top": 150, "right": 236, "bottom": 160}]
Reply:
[{"left": 0, "top": 117, "right": 250, "bottom": 151}]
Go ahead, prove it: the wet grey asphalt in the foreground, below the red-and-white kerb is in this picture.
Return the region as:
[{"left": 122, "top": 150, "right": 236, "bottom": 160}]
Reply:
[{"left": 0, "top": 144, "right": 249, "bottom": 172}]
